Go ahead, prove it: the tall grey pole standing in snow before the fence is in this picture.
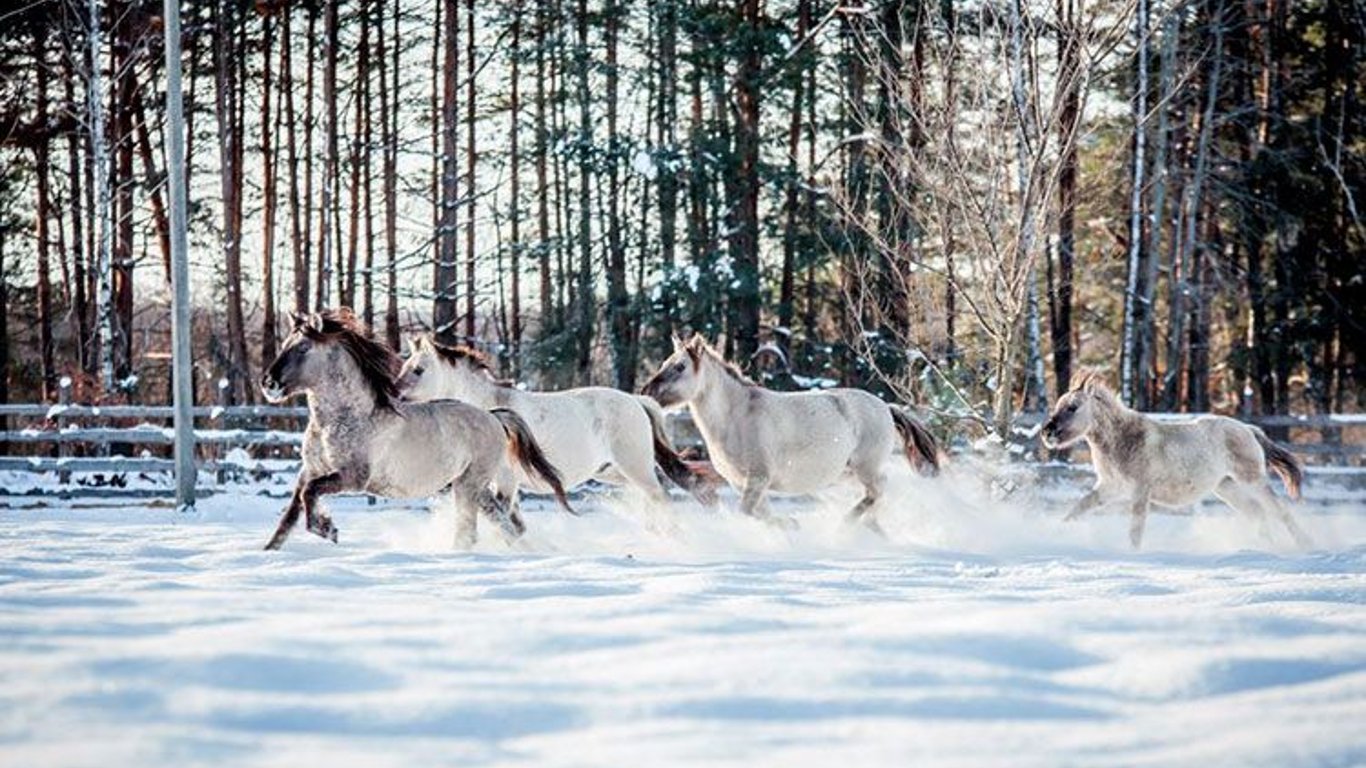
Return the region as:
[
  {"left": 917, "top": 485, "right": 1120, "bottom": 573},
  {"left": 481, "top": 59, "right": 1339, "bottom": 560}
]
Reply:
[{"left": 164, "top": 0, "right": 197, "bottom": 510}]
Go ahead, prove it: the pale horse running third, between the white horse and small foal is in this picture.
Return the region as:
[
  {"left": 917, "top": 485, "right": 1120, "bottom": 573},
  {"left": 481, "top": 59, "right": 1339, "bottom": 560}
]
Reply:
[{"left": 642, "top": 335, "right": 938, "bottom": 533}]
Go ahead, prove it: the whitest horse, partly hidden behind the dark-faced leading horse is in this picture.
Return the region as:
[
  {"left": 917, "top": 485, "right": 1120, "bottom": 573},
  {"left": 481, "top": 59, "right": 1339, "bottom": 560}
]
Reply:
[{"left": 399, "top": 336, "right": 716, "bottom": 506}]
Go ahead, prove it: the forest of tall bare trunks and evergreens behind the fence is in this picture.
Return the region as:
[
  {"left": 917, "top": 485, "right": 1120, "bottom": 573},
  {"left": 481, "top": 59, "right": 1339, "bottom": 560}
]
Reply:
[{"left": 0, "top": 0, "right": 1366, "bottom": 429}]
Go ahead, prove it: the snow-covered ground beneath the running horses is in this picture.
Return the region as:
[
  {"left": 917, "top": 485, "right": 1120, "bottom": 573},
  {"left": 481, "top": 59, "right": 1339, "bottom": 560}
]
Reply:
[{"left": 0, "top": 464, "right": 1366, "bottom": 768}]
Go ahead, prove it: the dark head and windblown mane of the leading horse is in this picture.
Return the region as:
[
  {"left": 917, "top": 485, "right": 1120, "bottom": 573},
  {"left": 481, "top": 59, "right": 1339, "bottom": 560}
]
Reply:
[{"left": 261, "top": 307, "right": 398, "bottom": 407}]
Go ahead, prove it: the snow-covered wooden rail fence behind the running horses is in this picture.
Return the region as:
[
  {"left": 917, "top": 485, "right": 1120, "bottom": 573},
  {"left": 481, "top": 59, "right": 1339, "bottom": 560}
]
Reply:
[{"left": 0, "top": 396, "right": 1366, "bottom": 497}]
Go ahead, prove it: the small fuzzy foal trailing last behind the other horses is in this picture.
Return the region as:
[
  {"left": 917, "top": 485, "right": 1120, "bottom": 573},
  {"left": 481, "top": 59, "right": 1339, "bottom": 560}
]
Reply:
[{"left": 1042, "top": 374, "right": 1310, "bottom": 549}]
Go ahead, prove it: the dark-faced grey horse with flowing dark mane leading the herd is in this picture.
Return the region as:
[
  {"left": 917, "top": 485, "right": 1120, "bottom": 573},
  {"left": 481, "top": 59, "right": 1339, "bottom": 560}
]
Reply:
[{"left": 261, "top": 307, "right": 574, "bottom": 549}]
